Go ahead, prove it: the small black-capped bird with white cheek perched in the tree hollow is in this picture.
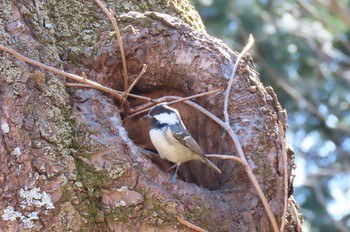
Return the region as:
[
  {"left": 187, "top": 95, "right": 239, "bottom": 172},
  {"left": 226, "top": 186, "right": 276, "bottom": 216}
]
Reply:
[{"left": 145, "top": 103, "right": 221, "bottom": 184}]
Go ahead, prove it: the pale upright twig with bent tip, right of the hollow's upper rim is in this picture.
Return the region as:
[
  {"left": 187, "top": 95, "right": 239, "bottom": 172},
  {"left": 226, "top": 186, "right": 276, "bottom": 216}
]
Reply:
[{"left": 224, "top": 34, "right": 254, "bottom": 124}]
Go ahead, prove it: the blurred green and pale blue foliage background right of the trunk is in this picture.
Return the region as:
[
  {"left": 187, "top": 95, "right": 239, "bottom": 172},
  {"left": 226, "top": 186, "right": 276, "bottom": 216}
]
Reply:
[{"left": 191, "top": 0, "right": 350, "bottom": 231}]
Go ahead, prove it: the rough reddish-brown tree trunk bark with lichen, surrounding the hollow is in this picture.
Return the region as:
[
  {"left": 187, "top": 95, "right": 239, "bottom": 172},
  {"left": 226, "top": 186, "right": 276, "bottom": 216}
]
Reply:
[{"left": 0, "top": 0, "right": 300, "bottom": 231}]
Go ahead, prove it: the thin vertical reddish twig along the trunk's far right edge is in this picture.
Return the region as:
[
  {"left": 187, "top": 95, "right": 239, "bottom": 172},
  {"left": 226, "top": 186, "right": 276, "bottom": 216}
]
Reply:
[{"left": 278, "top": 122, "right": 288, "bottom": 232}]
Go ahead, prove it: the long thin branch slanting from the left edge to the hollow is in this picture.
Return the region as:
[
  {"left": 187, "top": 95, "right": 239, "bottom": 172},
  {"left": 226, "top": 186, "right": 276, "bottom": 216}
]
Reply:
[{"left": 0, "top": 44, "right": 124, "bottom": 101}]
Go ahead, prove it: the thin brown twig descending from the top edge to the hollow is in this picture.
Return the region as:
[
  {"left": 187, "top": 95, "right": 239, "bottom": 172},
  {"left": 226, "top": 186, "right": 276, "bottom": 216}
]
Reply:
[{"left": 95, "top": 0, "right": 128, "bottom": 91}]
